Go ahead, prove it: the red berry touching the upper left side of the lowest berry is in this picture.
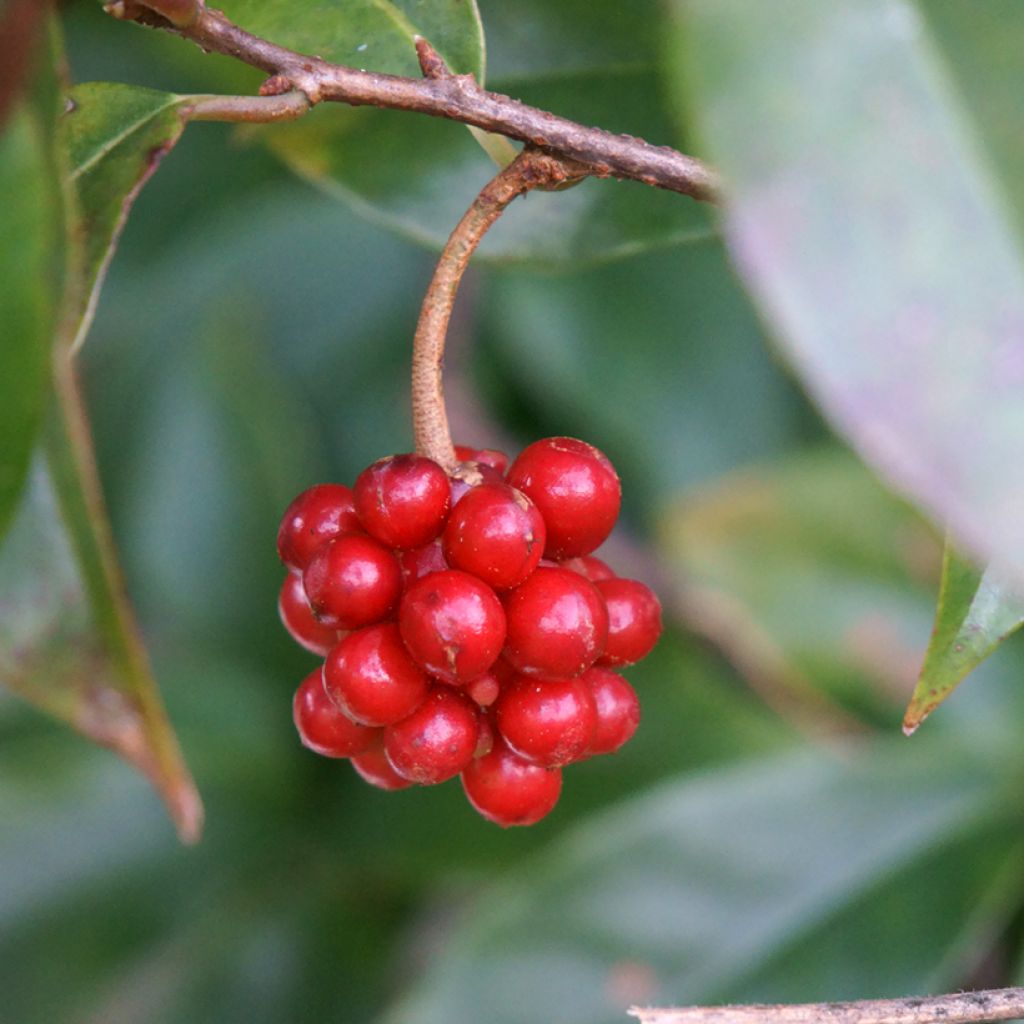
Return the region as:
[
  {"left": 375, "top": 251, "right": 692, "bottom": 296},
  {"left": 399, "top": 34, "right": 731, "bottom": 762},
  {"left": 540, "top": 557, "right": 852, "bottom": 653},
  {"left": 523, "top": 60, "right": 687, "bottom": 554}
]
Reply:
[{"left": 384, "top": 686, "right": 480, "bottom": 785}]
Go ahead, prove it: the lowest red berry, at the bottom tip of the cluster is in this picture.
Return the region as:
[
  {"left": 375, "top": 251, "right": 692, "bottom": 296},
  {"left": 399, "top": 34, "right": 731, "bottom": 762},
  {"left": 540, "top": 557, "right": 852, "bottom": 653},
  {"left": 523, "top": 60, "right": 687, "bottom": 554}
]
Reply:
[{"left": 462, "top": 736, "right": 562, "bottom": 828}]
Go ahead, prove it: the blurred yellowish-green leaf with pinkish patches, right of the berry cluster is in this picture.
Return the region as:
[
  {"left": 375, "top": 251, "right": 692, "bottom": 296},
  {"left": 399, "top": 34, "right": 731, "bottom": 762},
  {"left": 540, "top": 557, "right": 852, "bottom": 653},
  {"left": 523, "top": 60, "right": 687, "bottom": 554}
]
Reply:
[{"left": 663, "top": 450, "right": 939, "bottom": 721}]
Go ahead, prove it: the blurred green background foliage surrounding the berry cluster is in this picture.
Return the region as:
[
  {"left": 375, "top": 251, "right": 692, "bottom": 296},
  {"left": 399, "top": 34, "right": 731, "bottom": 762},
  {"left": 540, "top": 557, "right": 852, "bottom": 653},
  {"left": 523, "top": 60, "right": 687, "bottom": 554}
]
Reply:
[{"left": 0, "top": 0, "right": 1024, "bottom": 1024}]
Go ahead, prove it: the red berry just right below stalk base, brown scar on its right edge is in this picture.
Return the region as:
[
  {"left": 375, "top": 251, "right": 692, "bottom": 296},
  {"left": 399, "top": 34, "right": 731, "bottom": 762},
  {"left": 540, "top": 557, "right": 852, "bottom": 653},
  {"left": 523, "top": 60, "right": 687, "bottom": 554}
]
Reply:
[{"left": 441, "top": 483, "right": 547, "bottom": 590}]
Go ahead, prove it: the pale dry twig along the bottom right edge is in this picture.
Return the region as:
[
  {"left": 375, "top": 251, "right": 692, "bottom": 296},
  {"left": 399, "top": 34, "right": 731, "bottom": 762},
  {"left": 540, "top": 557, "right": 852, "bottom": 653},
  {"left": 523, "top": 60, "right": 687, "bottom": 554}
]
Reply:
[{"left": 630, "top": 988, "right": 1024, "bottom": 1024}]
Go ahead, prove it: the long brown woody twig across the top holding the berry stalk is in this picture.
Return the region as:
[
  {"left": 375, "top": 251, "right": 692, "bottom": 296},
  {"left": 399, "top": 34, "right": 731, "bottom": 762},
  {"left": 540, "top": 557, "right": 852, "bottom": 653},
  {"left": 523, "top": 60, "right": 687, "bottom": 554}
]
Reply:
[{"left": 99, "top": 0, "right": 718, "bottom": 202}]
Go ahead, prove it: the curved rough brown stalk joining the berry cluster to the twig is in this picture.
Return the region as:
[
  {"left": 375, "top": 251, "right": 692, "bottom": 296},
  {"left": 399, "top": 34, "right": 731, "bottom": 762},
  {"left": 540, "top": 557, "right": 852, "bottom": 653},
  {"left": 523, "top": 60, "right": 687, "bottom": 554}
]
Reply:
[{"left": 413, "top": 145, "right": 592, "bottom": 473}]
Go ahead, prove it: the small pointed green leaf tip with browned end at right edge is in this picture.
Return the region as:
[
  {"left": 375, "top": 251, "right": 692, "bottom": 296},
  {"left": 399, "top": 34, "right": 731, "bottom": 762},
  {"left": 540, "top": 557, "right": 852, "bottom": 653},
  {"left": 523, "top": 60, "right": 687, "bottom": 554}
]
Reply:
[{"left": 903, "top": 542, "right": 1024, "bottom": 735}]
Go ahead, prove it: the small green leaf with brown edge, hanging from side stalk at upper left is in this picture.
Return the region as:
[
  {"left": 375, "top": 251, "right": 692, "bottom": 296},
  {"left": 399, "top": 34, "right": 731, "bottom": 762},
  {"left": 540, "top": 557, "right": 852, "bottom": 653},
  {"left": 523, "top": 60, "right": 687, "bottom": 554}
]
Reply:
[{"left": 59, "top": 82, "right": 184, "bottom": 348}]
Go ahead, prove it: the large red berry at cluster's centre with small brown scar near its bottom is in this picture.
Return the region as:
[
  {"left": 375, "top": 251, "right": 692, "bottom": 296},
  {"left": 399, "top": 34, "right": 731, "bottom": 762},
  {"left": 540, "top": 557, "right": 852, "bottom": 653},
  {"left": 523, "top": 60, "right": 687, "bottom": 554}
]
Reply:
[{"left": 398, "top": 569, "right": 505, "bottom": 686}]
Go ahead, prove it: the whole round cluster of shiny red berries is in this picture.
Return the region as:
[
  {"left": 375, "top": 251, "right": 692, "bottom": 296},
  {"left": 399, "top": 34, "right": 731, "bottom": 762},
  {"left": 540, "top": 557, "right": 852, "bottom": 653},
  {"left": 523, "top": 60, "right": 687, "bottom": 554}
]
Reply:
[{"left": 278, "top": 437, "right": 662, "bottom": 825}]
